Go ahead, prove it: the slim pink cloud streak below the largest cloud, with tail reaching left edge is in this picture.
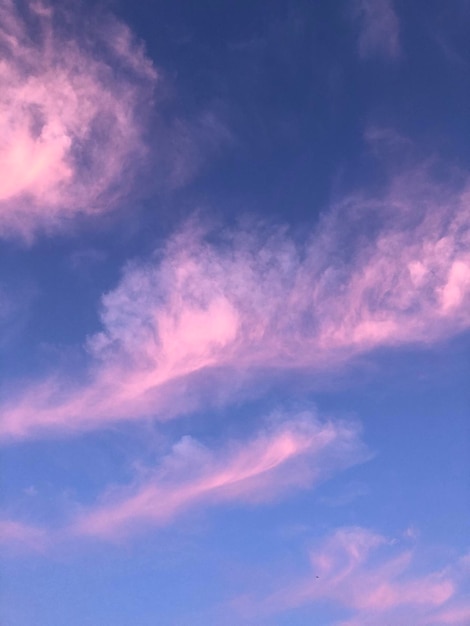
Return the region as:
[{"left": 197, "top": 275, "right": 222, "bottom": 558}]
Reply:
[{"left": 0, "top": 411, "right": 371, "bottom": 552}]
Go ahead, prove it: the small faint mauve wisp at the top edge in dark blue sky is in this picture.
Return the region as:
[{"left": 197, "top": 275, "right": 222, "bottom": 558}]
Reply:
[{"left": 352, "top": 0, "right": 401, "bottom": 59}]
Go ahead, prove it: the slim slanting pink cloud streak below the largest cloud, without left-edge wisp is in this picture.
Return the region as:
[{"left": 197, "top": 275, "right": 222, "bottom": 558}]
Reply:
[{"left": 69, "top": 414, "right": 366, "bottom": 539}]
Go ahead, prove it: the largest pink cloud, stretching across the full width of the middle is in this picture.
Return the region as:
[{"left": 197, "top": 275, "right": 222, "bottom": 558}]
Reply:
[{"left": 0, "top": 161, "right": 470, "bottom": 437}]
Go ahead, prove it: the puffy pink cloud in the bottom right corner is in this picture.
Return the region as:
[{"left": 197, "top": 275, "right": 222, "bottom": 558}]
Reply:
[{"left": 248, "top": 527, "right": 469, "bottom": 626}]
